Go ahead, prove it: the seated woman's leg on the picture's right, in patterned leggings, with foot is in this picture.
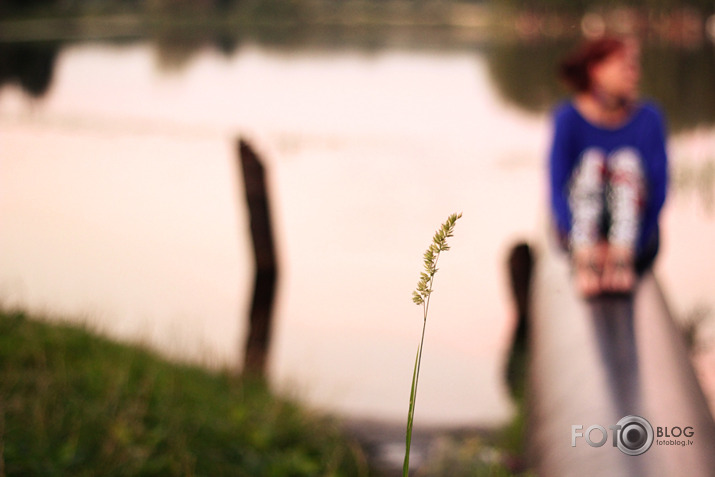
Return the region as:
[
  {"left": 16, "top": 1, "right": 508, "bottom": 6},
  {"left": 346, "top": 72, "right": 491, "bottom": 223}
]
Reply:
[{"left": 601, "top": 148, "right": 645, "bottom": 292}]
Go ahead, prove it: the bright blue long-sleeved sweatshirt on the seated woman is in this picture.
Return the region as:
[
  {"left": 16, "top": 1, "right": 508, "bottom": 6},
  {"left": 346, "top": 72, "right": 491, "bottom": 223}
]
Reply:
[{"left": 549, "top": 101, "right": 668, "bottom": 254}]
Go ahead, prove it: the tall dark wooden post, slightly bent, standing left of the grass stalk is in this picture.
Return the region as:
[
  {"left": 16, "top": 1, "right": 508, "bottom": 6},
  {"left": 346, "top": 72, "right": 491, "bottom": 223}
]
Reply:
[{"left": 238, "top": 139, "right": 278, "bottom": 376}]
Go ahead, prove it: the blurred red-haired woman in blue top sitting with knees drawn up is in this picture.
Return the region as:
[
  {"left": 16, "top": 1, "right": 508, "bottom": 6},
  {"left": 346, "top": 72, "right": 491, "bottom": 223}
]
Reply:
[{"left": 549, "top": 37, "right": 668, "bottom": 297}]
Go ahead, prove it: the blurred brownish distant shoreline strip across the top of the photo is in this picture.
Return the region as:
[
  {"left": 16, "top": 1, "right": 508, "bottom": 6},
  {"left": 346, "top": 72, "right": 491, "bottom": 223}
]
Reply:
[{"left": 0, "top": 0, "right": 715, "bottom": 47}]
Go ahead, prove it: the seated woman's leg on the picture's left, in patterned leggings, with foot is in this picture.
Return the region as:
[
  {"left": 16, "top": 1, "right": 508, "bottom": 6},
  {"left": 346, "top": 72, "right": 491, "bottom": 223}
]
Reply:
[{"left": 569, "top": 149, "right": 606, "bottom": 296}]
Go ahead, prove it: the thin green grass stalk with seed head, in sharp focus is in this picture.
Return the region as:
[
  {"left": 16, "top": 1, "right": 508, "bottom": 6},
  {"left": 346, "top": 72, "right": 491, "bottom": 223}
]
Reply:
[{"left": 402, "top": 213, "right": 462, "bottom": 477}]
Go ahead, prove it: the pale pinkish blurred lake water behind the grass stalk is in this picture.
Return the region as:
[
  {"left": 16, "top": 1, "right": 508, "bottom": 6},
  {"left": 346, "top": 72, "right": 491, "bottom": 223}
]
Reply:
[{"left": 0, "top": 37, "right": 715, "bottom": 425}]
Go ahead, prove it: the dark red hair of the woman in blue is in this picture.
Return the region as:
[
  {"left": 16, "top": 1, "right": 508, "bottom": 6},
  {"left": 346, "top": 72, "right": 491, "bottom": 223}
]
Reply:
[{"left": 558, "top": 37, "right": 626, "bottom": 93}]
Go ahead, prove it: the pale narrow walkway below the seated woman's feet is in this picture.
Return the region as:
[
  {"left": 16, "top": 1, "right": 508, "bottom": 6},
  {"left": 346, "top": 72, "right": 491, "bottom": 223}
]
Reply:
[{"left": 527, "top": 235, "right": 715, "bottom": 477}]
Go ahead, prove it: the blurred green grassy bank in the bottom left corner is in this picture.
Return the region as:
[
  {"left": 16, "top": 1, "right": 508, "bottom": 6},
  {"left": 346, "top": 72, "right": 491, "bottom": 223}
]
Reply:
[{"left": 0, "top": 311, "right": 368, "bottom": 477}]
